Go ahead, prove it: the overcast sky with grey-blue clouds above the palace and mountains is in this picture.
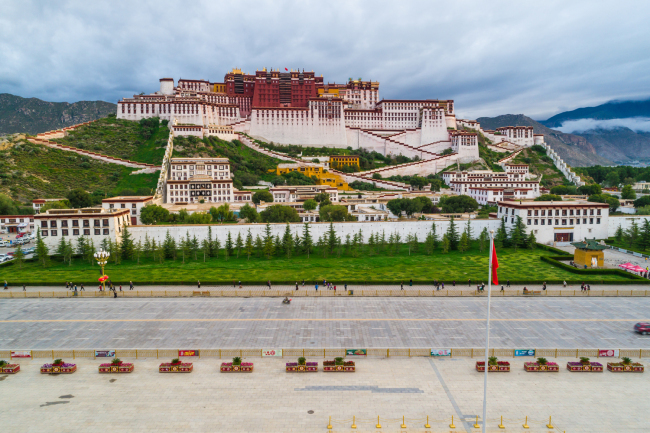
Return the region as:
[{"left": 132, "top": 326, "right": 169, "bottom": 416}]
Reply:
[{"left": 0, "top": 0, "right": 650, "bottom": 119}]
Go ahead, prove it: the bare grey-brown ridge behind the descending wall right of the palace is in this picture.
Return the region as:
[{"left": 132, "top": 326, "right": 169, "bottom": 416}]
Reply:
[{"left": 476, "top": 114, "right": 612, "bottom": 167}]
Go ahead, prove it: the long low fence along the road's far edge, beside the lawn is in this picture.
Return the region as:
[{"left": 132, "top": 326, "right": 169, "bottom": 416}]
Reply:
[{"left": 0, "top": 289, "right": 650, "bottom": 299}]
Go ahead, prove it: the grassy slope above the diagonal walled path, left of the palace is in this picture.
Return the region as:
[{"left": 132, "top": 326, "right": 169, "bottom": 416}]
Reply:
[{"left": 54, "top": 117, "right": 169, "bottom": 165}]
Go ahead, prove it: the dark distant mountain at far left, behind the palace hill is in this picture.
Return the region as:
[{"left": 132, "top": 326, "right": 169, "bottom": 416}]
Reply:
[{"left": 0, "top": 93, "right": 117, "bottom": 135}]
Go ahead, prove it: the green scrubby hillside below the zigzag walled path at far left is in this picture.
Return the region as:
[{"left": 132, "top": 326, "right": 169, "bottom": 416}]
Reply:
[{"left": 0, "top": 136, "right": 160, "bottom": 202}]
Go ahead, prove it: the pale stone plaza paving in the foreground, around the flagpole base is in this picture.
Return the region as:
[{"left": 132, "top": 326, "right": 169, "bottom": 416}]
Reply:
[{"left": 0, "top": 358, "right": 649, "bottom": 433}]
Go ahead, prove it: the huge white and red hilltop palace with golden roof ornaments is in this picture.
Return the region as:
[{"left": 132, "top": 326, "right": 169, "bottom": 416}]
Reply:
[{"left": 117, "top": 68, "right": 544, "bottom": 166}]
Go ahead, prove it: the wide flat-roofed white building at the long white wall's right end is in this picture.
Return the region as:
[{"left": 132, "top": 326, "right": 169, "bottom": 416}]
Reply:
[{"left": 497, "top": 201, "right": 609, "bottom": 244}]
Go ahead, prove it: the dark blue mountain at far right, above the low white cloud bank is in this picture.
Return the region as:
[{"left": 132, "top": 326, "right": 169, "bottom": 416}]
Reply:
[{"left": 540, "top": 99, "right": 650, "bottom": 128}]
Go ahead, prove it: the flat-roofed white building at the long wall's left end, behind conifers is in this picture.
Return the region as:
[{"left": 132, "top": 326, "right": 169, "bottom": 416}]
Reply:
[{"left": 34, "top": 208, "right": 131, "bottom": 254}]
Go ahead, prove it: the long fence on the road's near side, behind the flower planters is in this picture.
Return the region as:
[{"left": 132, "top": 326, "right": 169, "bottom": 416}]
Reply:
[{"left": 0, "top": 348, "right": 650, "bottom": 359}]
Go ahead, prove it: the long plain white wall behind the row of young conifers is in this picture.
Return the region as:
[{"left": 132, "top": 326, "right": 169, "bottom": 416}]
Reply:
[{"left": 129, "top": 219, "right": 501, "bottom": 246}]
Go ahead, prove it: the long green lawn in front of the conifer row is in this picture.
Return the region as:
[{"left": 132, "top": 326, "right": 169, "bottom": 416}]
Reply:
[{"left": 0, "top": 246, "right": 630, "bottom": 285}]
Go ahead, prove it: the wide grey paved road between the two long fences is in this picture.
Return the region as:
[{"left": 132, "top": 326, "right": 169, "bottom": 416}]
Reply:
[{"left": 0, "top": 298, "right": 650, "bottom": 349}]
